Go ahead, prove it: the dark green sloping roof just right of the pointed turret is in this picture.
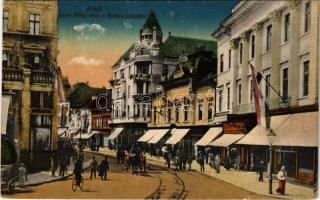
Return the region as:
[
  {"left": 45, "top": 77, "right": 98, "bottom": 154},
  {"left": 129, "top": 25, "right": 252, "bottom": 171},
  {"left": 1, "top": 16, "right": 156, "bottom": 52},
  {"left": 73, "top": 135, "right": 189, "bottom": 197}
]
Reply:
[{"left": 161, "top": 35, "right": 217, "bottom": 58}]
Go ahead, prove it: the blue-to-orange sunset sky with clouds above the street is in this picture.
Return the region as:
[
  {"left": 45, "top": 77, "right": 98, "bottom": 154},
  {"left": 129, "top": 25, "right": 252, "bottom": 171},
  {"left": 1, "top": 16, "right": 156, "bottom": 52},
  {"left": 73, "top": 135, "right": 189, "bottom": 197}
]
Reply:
[{"left": 58, "top": 0, "right": 238, "bottom": 87}]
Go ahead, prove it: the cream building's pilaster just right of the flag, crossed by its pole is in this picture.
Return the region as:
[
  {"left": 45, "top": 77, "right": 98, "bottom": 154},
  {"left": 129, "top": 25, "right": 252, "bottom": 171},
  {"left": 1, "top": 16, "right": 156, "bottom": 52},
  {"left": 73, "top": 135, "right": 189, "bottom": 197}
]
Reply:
[{"left": 270, "top": 10, "right": 281, "bottom": 108}]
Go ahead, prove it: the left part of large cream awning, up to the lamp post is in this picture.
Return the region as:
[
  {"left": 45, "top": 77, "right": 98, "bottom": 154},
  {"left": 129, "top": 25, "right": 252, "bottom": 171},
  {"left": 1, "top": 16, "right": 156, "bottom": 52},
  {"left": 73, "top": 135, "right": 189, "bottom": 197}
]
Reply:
[{"left": 236, "top": 125, "right": 270, "bottom": 146}]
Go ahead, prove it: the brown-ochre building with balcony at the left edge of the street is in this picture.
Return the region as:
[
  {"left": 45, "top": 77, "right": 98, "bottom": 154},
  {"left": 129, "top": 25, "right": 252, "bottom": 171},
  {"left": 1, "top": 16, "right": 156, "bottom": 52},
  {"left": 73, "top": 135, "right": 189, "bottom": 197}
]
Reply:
[{"left": 2, "top": 1, "right": 58, "bottom": 168}]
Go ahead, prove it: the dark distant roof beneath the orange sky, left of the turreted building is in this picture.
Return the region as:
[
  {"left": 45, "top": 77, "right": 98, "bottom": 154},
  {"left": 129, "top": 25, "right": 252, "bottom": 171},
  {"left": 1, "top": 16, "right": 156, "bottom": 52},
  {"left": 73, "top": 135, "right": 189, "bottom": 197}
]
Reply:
[{"left": 68, "top": 83, "right": 106, "bottom": 108}]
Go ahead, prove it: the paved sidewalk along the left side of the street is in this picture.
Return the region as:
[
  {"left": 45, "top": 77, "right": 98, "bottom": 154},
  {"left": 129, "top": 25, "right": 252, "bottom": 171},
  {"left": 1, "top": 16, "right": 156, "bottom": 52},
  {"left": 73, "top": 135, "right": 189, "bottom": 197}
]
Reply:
[{"left": 15, "top": 161, "right": 90, "bottom": 187}]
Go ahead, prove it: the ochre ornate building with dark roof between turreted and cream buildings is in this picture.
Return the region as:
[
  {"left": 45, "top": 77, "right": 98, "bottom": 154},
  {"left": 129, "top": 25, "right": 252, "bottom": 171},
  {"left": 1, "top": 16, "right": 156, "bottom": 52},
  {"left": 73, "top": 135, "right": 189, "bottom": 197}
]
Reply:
[{"left": 148, "top": 49, "right": 221, "bottom": 155}]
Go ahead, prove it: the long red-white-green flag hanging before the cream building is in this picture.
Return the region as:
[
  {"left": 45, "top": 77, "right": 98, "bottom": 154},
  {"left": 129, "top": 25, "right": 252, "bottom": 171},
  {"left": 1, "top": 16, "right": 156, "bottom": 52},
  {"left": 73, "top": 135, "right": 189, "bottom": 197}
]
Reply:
[{"left": 249, "top": 63, "right": 270, "bottom": 129}]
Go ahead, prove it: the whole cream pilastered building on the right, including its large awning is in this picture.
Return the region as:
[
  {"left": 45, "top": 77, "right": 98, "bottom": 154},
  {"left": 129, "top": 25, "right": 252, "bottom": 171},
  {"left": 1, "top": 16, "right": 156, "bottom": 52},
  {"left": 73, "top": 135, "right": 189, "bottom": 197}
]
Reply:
[{"left": 213, "top": 0, "right": 320, "bottom": 182}]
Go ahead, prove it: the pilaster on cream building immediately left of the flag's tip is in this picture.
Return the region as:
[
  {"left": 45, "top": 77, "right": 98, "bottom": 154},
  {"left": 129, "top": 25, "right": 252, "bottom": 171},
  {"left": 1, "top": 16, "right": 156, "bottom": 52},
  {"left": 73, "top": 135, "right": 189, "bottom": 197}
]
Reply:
[{"left": 240, "top": 31, "right": 250, "bottom": 112}]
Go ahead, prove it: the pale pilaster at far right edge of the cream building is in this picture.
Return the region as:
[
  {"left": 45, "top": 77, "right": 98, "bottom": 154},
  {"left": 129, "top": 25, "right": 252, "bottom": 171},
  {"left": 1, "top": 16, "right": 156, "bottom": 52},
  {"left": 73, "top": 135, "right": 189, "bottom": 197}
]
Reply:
[{"left": 308, "top": 1, "right": 320, "bottom": 104}]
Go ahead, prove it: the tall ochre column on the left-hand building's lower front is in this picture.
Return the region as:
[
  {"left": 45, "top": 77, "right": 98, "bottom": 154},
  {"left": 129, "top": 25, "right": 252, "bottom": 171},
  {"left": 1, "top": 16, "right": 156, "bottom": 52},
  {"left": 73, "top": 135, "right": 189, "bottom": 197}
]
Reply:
[{"left": 20, "top": 69, "right": 32, "bottom": 155}]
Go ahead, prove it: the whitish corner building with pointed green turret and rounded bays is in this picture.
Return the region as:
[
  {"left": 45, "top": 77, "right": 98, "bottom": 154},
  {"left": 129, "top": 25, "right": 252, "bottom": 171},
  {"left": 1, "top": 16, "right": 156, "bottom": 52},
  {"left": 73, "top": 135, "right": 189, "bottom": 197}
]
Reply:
[{"left": 110, "top": 12, "right": 182, "bottom": 148}]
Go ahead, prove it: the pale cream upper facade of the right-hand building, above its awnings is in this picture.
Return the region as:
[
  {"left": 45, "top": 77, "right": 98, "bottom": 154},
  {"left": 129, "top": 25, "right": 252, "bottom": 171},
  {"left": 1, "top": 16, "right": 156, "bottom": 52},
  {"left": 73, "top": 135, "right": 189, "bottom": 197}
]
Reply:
[{"left": 213, "top": 1, "right": 319, "bottom": 119}]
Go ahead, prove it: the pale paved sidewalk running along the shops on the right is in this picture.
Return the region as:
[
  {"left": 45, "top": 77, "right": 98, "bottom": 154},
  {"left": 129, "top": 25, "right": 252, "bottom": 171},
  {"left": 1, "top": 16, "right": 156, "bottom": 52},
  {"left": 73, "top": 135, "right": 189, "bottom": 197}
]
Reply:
[{"left": 86, "top": 148, "right": 317, "bottom": 199}]
